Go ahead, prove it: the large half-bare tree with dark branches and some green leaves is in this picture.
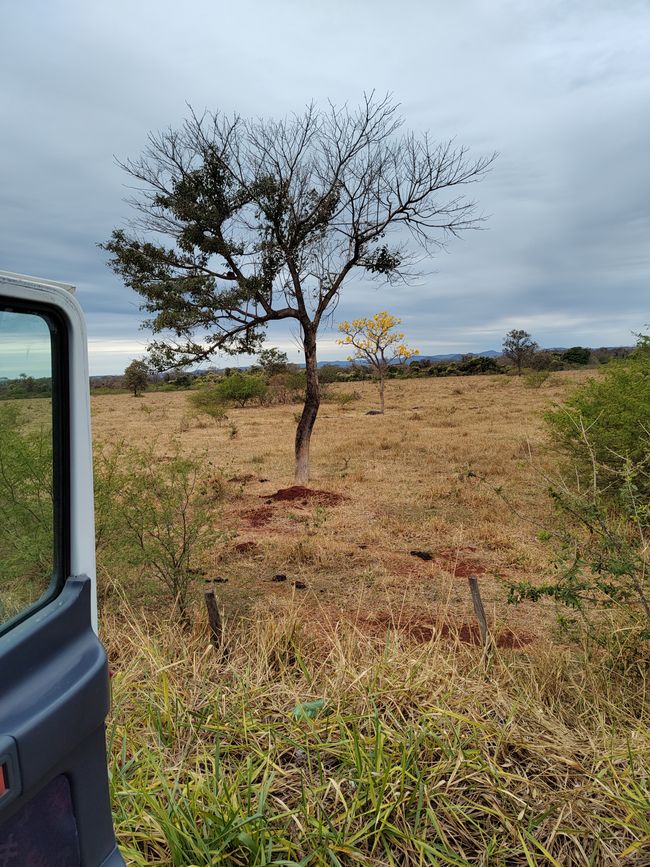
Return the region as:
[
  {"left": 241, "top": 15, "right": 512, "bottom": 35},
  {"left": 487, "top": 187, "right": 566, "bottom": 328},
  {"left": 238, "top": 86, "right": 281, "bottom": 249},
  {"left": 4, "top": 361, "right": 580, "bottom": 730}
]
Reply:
[{"left": 103, "top": 100, "right": 494, "bottom": 484}]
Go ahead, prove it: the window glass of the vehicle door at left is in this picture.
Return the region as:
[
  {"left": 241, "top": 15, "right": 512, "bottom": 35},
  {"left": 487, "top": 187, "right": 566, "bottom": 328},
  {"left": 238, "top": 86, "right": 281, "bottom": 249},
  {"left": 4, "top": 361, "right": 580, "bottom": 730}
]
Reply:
[{"left": 0, "top": 310, "right": 58, "bottom": 630}]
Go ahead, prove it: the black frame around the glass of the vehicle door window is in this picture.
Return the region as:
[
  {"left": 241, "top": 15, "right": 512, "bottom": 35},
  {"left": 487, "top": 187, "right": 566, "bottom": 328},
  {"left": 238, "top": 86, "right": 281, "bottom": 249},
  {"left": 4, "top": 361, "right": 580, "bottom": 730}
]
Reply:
[{"left": 0, "top": 295, "right": 71, "bottom": 636}]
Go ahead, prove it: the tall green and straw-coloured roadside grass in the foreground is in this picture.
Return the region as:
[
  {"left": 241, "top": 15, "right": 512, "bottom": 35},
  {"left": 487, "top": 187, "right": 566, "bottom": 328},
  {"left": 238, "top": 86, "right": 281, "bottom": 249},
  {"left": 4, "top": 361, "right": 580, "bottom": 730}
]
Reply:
[{"left": 104, "top": 610, "right": 650, "bottom": 867}]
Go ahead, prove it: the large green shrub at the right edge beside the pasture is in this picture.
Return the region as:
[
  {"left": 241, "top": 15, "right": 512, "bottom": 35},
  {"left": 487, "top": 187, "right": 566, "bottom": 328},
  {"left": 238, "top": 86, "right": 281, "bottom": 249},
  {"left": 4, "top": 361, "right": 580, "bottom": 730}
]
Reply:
[{"left": 509, "top": 338, "right": 650, "bottom": 666}]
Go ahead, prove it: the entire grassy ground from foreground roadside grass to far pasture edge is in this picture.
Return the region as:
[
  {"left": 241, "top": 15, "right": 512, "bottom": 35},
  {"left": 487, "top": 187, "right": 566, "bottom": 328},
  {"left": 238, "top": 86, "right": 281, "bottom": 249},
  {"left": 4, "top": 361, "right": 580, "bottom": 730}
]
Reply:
[{"left": 92, "top": 372, "right": 650, "bottom": 865}]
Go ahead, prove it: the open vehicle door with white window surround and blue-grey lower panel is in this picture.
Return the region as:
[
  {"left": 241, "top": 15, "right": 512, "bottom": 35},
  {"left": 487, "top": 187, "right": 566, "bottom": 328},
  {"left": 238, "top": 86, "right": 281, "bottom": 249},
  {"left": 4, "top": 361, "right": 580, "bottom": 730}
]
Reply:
[{"left": 0, "top": 274, "right": 123, "bottom": 867}]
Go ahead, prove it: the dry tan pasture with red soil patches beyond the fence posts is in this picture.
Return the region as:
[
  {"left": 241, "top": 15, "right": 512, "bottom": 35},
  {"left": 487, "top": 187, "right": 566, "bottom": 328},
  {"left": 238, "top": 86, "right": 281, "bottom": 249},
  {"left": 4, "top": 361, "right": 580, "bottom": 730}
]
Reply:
[{"left": 92, "top": 373, "right": 584, "bottom": 635}]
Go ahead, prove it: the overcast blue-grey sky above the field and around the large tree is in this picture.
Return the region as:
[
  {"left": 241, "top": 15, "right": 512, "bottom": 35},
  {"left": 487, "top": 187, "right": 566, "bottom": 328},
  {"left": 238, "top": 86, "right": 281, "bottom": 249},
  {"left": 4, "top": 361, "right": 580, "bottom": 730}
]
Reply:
[{"left": 0, "top": 0, "right": 650, "bottom": 374}]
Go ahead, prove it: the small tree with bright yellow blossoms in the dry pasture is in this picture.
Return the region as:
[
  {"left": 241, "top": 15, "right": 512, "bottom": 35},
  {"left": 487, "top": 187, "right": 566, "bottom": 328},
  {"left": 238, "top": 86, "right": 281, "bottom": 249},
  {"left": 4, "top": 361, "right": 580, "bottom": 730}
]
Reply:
[{"left": 337, "top": 310, "right": 420, "bottom": 412}]
